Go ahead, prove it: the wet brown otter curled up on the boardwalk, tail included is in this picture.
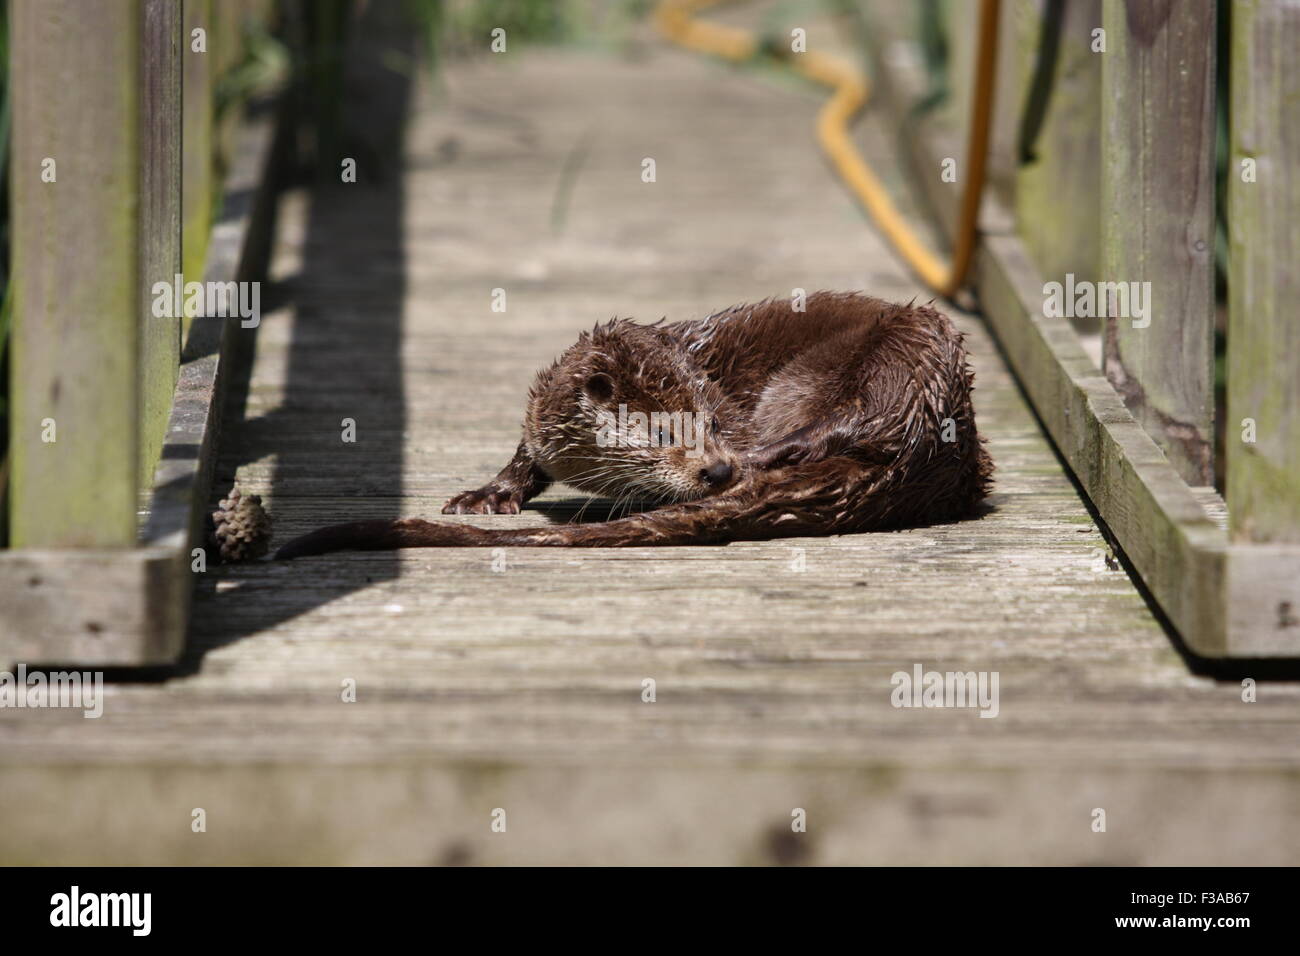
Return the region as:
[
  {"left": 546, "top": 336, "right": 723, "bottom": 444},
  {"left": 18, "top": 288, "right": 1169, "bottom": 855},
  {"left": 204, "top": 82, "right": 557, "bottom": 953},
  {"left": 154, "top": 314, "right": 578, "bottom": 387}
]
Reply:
[{"left": 276, "top": 293, "right": 993, "bottom": 558}]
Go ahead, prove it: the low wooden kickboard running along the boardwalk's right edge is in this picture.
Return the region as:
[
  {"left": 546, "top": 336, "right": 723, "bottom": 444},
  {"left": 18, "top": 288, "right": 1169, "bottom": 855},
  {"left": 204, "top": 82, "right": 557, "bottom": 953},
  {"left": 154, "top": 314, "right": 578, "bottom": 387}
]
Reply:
[{"left": 867, "top": 0, "right": 1300, "bottom": 657}]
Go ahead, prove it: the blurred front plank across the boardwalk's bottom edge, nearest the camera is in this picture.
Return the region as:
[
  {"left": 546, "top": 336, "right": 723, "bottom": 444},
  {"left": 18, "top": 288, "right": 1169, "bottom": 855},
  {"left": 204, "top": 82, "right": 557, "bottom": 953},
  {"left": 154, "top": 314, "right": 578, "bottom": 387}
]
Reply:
[{"left": 0, "top": 764, "right": 1300, "bottom": 866}]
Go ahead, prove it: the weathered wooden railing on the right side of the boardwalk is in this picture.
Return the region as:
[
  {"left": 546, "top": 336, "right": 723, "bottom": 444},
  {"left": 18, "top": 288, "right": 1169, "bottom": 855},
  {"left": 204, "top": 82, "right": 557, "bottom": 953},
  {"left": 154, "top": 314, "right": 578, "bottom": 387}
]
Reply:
[{"left": 861, "top": 0, "right": 1300, "bottom": 657}]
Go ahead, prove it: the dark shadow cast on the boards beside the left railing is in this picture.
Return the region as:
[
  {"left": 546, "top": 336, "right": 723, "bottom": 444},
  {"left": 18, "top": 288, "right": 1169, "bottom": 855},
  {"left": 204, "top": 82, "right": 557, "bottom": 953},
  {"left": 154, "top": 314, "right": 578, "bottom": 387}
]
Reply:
[{"left": 181, "top": 4, "right": 415, "bottom": 672}]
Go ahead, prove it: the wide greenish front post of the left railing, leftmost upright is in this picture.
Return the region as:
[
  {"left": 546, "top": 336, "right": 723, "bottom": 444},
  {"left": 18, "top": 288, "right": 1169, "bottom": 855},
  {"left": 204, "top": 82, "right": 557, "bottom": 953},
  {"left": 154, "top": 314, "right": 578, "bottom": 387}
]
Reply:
[{"left": 9, "top": 0, "right": 148, "bottom": 548}]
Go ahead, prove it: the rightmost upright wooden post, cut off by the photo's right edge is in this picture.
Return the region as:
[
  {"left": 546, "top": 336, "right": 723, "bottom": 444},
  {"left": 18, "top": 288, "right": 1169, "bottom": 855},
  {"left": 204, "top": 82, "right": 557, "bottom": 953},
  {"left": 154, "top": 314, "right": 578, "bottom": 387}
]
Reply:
[{"left": 1226, "top": 0, "right": 1300, "bottom": 544}]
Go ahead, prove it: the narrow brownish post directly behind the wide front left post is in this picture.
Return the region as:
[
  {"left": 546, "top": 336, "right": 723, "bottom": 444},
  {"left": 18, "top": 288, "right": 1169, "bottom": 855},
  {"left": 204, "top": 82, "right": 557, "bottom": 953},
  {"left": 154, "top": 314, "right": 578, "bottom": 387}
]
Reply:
[{"left": 138, "top": 0, "right": 183, "bottom": 488}]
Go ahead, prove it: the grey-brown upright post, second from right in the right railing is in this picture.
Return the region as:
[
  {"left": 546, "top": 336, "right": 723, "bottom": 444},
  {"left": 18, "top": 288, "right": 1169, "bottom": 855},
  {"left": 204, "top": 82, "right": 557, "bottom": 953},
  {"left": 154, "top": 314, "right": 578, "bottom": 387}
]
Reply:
[{"left": 1099, "top": 0, "right": 1214, "bottom": 485}]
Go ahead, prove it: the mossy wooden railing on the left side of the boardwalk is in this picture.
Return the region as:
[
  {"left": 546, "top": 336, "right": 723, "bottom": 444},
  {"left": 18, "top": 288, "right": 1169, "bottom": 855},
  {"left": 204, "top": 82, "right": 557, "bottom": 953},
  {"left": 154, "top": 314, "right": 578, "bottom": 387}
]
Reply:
[{"left": 0, "top": 0, "right": 273, "bottom": 665}]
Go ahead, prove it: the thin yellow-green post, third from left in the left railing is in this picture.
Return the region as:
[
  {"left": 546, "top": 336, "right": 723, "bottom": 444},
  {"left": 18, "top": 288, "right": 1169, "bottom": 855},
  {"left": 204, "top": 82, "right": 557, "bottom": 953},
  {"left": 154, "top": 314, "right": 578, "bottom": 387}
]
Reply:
[{"left": 181, "top": 0, "right": 216, "bottom": 343}]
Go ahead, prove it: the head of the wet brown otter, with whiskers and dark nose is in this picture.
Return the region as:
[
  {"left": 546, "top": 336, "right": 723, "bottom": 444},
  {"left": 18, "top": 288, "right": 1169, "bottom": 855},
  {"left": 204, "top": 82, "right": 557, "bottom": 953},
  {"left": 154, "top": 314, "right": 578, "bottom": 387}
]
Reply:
[{"left": 525, "top": 319, "right": 741, "bottom": 501}]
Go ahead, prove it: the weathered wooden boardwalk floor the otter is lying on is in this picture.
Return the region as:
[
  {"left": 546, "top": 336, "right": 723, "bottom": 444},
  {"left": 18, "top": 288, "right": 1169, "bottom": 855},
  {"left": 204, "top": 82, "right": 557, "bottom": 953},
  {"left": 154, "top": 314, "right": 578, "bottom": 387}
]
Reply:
[{"left": 0, "top": 11, "right": 1300, "bottom": 864}]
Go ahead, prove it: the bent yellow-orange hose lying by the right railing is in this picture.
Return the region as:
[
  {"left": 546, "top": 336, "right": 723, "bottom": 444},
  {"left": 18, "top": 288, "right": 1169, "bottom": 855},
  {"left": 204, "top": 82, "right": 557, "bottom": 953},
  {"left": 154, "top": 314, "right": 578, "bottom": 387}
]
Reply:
[{"left": 655, "top": 0, "right": 998, "bottom": 298}]
